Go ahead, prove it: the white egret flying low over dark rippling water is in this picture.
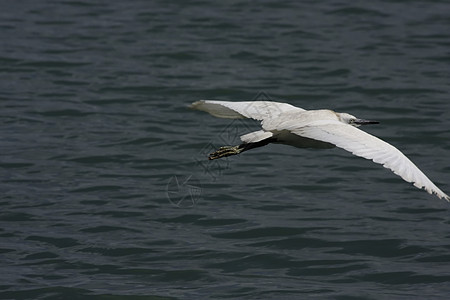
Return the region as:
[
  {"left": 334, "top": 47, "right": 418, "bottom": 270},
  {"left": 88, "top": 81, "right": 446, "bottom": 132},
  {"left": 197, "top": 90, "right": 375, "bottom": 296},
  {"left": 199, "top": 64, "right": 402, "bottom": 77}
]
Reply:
[{"left": 190, "top": 100, "right": 450, "bottom": 202}]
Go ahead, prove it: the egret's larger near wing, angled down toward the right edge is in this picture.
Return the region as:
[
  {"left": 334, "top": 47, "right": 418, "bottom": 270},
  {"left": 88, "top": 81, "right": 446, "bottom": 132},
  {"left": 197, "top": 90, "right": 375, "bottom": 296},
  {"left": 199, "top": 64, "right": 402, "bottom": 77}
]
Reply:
[{"left": 290, "top": 120, "right": 450, "bottom": 201}]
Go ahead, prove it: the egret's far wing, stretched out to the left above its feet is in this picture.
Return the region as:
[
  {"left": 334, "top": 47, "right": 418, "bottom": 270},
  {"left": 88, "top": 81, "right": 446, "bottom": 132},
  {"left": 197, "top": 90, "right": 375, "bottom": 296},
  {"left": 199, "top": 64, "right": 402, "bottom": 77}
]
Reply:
[{"left": 190, "top": 100, "right": 305, "bottom": 121}]
